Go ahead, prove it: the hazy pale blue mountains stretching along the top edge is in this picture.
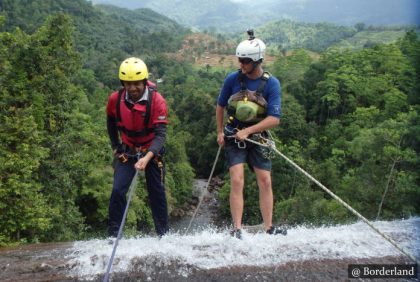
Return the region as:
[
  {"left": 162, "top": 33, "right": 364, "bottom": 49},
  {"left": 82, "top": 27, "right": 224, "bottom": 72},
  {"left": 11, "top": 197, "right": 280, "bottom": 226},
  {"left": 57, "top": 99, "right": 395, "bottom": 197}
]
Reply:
[{"left": 92, "top": 0, "right": 420, "bottom": 32}]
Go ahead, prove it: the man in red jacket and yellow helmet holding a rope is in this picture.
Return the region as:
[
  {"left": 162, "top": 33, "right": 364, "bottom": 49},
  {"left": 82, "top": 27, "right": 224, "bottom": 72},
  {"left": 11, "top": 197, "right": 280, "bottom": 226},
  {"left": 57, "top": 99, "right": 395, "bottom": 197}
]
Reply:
[{"left": 106, "top": 58, "right": 169, "bottom": 237}]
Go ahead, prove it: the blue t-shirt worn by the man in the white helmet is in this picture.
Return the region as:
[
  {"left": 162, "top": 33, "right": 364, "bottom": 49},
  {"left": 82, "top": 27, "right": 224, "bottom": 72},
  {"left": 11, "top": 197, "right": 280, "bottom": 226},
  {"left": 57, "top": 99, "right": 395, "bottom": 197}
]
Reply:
[{"left": 217, "top": 71, "right": 281, "bottom": 118}]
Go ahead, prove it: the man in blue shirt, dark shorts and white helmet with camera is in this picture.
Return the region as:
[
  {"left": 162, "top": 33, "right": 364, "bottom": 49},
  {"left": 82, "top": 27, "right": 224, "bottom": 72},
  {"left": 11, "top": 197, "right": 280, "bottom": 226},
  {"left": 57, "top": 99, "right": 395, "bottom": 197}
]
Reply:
[{"left": 216, "top": 31, "right": 287, "bottom": 238}]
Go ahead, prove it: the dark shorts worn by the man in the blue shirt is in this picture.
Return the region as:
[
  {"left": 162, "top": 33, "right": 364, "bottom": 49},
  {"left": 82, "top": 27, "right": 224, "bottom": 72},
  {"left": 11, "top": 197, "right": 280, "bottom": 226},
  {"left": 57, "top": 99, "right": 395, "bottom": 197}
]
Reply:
[{"left": 225, "top": 127, "right": 271, "bottom": 171}]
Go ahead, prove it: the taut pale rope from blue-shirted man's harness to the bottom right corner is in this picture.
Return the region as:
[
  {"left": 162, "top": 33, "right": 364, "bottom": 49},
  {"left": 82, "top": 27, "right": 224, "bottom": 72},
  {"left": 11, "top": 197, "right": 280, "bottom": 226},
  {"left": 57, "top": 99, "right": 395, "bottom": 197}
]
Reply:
[{"left": 245, "top": 133, "right": 419, "bottom": 263}]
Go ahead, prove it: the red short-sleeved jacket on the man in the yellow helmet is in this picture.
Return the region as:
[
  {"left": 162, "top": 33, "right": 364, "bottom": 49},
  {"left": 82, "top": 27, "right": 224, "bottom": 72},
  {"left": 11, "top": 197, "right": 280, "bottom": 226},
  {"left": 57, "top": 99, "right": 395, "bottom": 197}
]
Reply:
[{"left": 106, "top": 82, "right": 168, "bottom": 148}]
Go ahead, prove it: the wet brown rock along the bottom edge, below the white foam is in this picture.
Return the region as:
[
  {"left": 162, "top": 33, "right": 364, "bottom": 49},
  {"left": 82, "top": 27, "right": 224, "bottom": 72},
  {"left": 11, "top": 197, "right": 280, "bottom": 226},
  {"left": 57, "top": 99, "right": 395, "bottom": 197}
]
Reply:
[{"left": 0, "top": 244, "right": 411, "bottom": 282}]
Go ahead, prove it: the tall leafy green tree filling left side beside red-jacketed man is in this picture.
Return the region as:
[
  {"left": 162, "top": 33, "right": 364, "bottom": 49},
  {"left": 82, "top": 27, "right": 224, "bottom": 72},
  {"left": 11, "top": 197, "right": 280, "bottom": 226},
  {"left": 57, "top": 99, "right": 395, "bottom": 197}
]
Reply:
[{"left": 0, "top": 15, "right": 111, "bottom": 241}]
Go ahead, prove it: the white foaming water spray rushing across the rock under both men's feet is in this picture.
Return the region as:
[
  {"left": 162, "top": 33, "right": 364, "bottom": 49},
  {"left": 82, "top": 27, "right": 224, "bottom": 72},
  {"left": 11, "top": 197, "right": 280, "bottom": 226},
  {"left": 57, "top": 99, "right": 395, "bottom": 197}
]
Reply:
[{"left": 68, "top": 217, "right": 420, "bottom": 279}]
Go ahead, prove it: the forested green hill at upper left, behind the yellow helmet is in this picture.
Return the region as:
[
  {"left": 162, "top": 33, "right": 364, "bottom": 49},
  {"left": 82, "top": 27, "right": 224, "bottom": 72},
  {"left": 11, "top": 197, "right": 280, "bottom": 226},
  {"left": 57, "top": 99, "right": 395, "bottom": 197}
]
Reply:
[{"left": 0, "top": 0, "right": 187, "bottom": 85}]
